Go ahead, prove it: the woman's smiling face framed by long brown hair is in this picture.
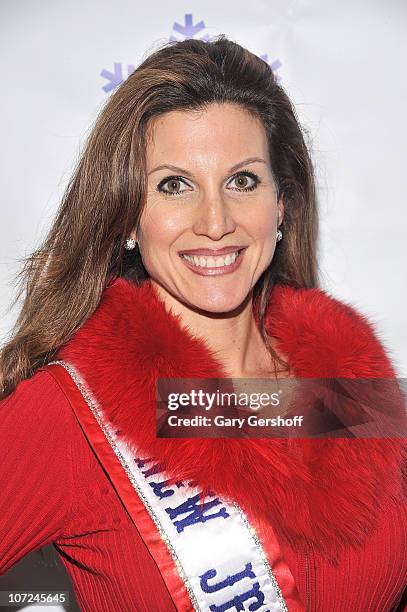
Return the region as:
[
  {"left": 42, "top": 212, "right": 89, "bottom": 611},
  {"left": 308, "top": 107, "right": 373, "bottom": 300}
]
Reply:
[{"left": 136, "top": 104, "right": 283, "bottom": 313}]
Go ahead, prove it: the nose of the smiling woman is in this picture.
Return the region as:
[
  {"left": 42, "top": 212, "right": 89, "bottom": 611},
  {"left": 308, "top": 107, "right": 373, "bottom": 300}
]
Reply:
[{"left": 192, "top": 196, "right": 236, "bottom": 240}]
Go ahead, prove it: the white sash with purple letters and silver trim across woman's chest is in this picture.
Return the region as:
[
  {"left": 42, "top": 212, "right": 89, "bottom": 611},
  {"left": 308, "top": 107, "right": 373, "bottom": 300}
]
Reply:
[{"left": 49, "top": 361, "right": 296, "bottom": 612}]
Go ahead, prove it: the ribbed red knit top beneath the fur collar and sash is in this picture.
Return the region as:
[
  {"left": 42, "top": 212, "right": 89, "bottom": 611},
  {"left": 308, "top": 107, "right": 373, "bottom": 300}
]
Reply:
[{"left": 0, "top": 281, "right": 407, "bottom": 612}]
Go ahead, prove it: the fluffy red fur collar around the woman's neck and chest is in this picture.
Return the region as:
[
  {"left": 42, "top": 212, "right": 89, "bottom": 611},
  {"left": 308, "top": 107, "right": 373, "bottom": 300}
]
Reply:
[{"left": 57, "top": 278, "right": 402, "bottom": 556}]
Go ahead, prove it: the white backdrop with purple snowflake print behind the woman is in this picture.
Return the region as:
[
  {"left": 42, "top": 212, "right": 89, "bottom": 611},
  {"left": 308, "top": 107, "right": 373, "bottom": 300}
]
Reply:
[{"left": 0, "top": 0, "right": 407, "bottom": 377}]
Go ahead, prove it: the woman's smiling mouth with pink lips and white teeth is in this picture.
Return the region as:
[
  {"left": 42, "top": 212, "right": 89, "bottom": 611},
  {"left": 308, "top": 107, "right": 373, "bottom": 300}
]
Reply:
[{"left": 180, "top": 246, "right": 245, "bottom": 276}]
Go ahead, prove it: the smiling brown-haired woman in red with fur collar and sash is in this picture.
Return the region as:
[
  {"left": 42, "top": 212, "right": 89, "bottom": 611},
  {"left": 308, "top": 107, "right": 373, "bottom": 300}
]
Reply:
[{"left": 0, "top": 36, "right": 407, "bottom": 612}]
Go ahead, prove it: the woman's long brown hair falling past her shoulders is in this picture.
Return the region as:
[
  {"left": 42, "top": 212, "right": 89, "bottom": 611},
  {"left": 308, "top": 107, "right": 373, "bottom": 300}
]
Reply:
[{"left": 0, "top": 35, "right": 318, "bottom": 398}]
